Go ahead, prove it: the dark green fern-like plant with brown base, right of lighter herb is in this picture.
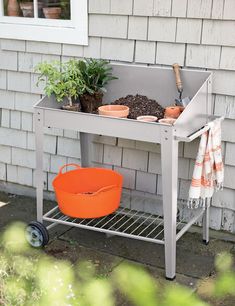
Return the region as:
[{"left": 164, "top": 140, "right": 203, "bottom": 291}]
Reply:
[{"left": 78, "top": 59, "right": 117, "bottom": 113}]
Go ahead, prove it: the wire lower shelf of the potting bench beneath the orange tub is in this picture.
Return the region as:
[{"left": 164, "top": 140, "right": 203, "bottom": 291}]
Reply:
[{"left": 43, "top": 206, "right": 204, "bottom": 244}]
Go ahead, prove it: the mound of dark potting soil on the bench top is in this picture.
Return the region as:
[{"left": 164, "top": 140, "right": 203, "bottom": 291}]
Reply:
[{"left": 112, "top": 95, "right": 164, "bottom": 119}]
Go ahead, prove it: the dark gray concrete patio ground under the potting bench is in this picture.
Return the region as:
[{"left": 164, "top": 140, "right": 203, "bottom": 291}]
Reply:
[{"left": 0, "top": 193, "right": 235, "bottom": 306}]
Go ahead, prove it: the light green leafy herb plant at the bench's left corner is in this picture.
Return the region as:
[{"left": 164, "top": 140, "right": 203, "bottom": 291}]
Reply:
[{"left": 35, "top": 59, "right": 86, "bottom": 111}]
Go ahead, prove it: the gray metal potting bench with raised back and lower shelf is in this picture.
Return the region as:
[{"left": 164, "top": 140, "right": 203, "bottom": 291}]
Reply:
[{"left": 31, "top": 64, "right": 215, "bottom": 279}]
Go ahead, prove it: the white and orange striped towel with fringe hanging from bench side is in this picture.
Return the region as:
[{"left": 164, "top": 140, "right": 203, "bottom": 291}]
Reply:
[{"left": 188, "top": 119, "right": 224, "bottom": 208}]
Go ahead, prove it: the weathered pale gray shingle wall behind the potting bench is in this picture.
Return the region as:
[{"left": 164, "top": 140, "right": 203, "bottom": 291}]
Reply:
[{"left": 0, "top": 0, "right": 235, "bottom": 231}]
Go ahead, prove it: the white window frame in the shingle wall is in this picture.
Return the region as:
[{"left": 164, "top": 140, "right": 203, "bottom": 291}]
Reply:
[{"left": 0, "top": 0, "right": 88, "bottom": 45}]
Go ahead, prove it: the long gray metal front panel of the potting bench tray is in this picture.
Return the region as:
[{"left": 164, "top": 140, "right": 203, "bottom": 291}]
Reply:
[{"left": 39, "top": 98, "right": 162, "bottom": 143}]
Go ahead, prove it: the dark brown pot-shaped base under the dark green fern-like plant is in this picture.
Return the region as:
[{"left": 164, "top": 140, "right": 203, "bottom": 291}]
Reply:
[{"left": 80, "top": 92, "right": 103, "bottom": 113}]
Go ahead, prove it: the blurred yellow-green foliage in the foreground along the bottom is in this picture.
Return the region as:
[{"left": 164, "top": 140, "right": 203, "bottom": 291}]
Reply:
[{"left": 0, "top": 223, "right": 235, "bottom": 306}]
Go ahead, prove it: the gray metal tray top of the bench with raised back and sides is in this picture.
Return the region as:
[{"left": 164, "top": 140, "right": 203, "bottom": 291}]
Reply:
[{"left": 35, "top": 65, "right": 212, "bottom": 143}]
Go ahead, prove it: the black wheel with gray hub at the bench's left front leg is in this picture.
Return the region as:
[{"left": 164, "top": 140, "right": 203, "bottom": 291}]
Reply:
[{"left": 25, "top": 221, "right": 49, "bottom": 248}]
